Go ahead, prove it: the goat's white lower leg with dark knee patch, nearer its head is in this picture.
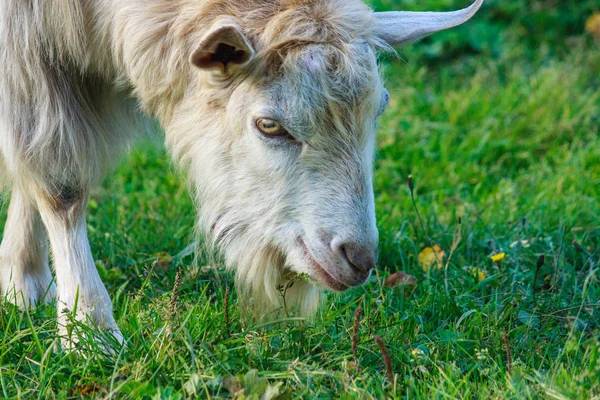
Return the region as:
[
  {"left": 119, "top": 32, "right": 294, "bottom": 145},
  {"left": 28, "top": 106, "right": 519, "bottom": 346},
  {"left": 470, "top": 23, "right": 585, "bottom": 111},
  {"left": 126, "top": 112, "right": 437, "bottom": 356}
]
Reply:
[{"left": 37, "top": 187, "right": 123, "bottom": 349}]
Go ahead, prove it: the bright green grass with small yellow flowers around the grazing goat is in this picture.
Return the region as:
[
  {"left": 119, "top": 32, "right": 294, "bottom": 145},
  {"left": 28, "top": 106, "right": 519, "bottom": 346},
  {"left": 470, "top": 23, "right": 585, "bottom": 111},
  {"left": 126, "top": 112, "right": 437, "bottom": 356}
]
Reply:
[{"left": 0, "top": 3, "right": 600, "bottom": 399}]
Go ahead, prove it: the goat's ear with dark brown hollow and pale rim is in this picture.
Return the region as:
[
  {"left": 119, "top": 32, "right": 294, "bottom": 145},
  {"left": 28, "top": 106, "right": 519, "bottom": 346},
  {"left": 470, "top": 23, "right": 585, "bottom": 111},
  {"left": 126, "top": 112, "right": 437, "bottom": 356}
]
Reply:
[{"left": 190, "top": 21, "right": 254, "bottom": 74}]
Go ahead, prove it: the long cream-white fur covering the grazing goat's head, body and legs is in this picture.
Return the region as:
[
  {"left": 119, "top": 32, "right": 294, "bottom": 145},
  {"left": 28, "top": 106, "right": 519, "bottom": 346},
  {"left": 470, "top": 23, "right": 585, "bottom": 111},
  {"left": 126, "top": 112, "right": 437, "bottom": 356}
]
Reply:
[{"left": 0, "top": 0, "right": 481, "bottom": 344}]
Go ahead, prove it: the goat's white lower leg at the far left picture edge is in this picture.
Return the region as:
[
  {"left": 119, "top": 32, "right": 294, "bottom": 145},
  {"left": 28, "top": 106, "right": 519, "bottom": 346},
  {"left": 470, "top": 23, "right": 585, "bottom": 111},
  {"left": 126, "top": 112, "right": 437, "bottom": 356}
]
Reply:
[{"left": 0, "top": 187, "right": 56, "bottom": 309}]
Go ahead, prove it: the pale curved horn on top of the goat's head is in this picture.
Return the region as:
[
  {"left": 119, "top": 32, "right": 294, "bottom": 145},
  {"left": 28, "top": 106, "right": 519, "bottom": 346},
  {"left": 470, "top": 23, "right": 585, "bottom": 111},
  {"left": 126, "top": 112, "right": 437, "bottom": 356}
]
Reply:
[{"left": 375, "top": 0, "right": 483, "bottom": 46}]
